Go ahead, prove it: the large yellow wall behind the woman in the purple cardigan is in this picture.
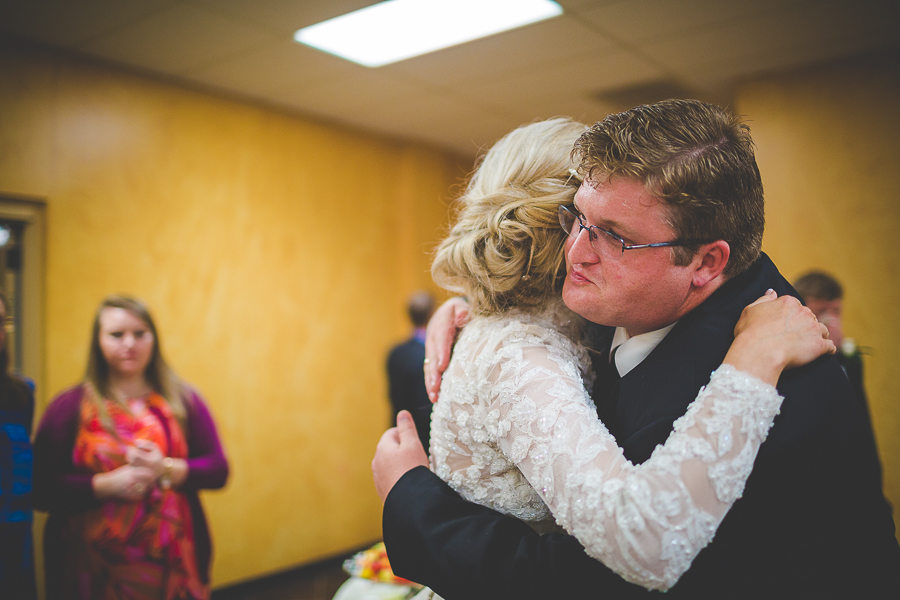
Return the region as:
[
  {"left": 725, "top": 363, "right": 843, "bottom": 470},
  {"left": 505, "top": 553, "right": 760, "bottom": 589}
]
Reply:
[{"left": 0, "top": 42, "right": 461, "bottom": 586}]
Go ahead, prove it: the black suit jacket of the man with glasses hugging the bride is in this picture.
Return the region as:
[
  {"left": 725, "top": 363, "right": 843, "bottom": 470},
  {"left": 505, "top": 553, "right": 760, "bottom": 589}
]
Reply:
[{"left": 383, "top": 255, "right": 900, "bottom": 600}]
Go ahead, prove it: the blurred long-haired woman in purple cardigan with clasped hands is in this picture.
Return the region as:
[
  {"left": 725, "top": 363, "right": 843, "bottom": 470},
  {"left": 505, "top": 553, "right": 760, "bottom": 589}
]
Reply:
[{"left": 34, "top": 296, "right": 228, "bottom": 600}]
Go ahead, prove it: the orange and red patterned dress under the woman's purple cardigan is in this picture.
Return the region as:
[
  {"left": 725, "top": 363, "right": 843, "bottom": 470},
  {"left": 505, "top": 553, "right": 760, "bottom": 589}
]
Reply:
[{"left": 69, "top": 393, "right": 209, "bottom": 600}]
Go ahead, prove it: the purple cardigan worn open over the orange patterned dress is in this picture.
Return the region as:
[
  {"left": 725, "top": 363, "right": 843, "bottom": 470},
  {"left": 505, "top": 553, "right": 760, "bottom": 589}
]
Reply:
[{"left": 32, "top": 386, "right": 228, "bottom": 584}]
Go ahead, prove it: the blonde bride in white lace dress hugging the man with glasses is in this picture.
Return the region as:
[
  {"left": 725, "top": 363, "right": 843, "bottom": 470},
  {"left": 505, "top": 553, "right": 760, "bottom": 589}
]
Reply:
[{"left": 422, "top": 118, "right": 833, "bottom": 597}]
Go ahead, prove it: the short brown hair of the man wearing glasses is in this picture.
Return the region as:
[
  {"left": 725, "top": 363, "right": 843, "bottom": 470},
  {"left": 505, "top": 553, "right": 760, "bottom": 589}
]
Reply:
[{"left": 573, "top": 100, "right": 765, "bottom": 277}]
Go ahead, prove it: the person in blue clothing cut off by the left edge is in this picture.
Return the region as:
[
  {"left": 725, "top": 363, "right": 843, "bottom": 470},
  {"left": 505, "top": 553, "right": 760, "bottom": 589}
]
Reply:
[{"left": 0, "top": 292, "right": 36, "bottom": 600}]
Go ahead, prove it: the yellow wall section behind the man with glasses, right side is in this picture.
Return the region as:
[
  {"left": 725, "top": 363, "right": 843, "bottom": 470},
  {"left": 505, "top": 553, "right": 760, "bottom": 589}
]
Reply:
[{"left": 737, "top": 48, "right": 900, "bottom": 536}]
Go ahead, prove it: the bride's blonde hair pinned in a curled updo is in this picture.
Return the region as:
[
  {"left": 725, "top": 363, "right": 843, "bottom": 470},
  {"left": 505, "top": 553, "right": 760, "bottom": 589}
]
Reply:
[{"left": 431, "top": 117, "right": 587, "bottom": 315}]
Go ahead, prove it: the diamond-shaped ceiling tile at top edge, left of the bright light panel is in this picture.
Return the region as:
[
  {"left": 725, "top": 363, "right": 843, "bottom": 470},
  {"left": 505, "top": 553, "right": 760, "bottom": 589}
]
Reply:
[{"left": 81, "top": 4, "right": 274, "bottom": 74}]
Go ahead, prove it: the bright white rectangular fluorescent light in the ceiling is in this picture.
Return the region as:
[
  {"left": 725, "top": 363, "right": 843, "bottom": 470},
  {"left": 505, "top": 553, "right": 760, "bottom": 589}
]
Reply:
[{"left": 294, "top": 0, "right": 562, "bottom": 67}]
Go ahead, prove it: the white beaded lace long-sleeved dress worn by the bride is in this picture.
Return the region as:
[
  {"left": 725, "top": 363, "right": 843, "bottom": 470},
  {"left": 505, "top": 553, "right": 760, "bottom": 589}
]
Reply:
[{"left": 431, "top": 309, "right": 782, "bottom": 590}]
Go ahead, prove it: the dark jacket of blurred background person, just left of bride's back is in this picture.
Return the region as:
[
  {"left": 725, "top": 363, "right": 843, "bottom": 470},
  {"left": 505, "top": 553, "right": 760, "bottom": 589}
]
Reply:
[{"left": 387, "top": 337, "right": 432, "bottom": 452}]
